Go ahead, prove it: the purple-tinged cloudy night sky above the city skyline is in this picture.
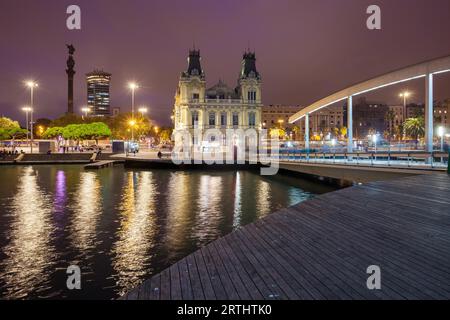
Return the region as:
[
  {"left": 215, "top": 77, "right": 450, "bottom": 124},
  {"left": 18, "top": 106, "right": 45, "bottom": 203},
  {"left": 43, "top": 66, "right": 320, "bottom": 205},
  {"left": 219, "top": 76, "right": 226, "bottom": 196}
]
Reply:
[{"left": 0, "top": 0, "right": 450, "bottom": 125}]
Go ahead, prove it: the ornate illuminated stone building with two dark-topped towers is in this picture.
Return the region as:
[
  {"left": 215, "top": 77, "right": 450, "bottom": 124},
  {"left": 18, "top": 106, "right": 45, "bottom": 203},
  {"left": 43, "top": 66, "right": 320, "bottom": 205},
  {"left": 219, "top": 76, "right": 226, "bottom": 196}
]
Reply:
[{"left": 173, "top": 50, "right": 262, "bottom": 145}]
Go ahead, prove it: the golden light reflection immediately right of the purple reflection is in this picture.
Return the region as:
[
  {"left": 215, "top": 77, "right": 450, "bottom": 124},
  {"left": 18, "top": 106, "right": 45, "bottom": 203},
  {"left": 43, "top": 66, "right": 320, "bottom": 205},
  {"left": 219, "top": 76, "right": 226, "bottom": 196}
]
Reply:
[{"left": 71, "top": 172, "right": 102, "bottom": 254}]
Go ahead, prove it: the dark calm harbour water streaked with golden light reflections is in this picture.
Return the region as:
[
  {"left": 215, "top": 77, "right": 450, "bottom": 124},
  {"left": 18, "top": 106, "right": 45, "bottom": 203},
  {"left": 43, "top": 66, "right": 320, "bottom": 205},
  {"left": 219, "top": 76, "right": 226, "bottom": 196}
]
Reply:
[{"left": 0, "top": 166, "right": 334, "bottom": 299}]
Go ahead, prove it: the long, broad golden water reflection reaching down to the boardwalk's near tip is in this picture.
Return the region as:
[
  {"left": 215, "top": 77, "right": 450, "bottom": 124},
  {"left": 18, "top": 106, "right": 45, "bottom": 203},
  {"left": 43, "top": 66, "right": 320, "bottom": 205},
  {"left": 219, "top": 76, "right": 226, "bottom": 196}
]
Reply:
[{"left": 113, "top": 171, "right": 158, "bottom": 294}]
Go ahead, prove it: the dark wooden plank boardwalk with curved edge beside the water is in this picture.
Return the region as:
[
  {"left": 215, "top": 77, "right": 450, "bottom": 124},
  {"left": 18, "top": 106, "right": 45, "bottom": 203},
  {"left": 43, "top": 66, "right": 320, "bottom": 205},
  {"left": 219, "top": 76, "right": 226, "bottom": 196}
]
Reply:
[{"left": 123, "top": 174, "right": 450, "bottom": 300}]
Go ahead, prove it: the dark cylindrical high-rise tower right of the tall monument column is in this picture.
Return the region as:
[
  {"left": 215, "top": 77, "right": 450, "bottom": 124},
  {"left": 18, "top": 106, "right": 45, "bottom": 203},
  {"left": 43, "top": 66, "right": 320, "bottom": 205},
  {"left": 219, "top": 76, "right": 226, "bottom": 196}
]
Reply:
[{"left": 86, "top": 70, "right": 111, "bottom": 117}]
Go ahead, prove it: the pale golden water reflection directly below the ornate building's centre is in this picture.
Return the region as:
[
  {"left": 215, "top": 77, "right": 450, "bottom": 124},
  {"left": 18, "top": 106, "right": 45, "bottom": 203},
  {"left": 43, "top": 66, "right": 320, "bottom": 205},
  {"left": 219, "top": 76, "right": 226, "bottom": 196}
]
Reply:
[{"left": 193, "top": 175, "right": 223, "bottom": 244}]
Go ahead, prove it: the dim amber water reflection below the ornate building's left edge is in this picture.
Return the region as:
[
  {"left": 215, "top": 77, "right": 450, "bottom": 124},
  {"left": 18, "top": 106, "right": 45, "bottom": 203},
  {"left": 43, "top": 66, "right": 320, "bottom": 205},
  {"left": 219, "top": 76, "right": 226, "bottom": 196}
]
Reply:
[{"left": 166, "top": 171, "right": 196, "bottom": 251}]
